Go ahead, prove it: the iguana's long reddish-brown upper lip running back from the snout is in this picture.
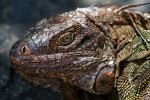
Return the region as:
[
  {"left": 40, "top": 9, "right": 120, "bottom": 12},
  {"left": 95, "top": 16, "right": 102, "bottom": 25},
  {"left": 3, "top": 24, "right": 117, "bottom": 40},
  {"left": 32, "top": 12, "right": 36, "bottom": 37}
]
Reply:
[{"left": 10, "top": 50, "right": 101, "bottom": 63}]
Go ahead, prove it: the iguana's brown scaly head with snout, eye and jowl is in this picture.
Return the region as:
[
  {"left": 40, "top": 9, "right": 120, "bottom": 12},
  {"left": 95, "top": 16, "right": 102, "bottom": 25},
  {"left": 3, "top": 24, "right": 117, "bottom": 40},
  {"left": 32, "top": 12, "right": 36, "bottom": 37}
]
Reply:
[{"left": 10, "top": 4, "right": 115, "bottom": 94}]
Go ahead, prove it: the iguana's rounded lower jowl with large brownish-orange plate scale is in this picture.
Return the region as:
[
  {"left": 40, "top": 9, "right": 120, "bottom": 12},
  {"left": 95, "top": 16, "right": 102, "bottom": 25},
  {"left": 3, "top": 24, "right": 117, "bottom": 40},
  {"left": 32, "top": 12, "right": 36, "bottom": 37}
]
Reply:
[{"left": 77, "top": 61, "right": 115, "bottom": 95}]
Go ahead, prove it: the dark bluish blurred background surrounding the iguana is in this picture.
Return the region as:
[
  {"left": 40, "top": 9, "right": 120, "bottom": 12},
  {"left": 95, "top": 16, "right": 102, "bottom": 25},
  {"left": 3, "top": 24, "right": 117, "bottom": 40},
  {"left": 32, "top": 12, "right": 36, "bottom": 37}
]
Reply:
[{"left": 0, "top": 0, "right": 149, "bottom": 100}]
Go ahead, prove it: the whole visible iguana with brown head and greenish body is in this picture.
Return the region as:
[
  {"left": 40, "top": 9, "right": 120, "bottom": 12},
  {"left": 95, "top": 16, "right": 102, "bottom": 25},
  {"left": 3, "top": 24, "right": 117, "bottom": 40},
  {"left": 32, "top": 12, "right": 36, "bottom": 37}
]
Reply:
[{"left": 10, "top": 1, "right": 150, "bottom": 100}]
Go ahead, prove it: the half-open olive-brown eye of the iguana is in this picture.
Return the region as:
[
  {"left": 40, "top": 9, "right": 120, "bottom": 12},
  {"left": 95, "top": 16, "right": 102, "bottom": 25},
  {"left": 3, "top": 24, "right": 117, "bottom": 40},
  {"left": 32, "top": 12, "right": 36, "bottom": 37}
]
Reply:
[{"left": 59, "top": 32, "right": 75, "bottom": 45}]
